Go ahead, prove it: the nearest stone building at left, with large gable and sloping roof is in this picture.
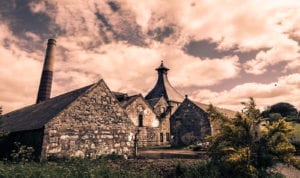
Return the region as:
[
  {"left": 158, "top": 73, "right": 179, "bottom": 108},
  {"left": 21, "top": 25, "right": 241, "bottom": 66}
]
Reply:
[{"left": 0, "top": 80, "right": 136, "bottom": 159}]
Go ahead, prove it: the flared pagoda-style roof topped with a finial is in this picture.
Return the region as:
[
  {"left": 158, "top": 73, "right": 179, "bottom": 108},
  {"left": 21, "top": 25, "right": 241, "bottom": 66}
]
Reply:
[{"left": 145, "top": 62, "right": 184, "bottom": 102}]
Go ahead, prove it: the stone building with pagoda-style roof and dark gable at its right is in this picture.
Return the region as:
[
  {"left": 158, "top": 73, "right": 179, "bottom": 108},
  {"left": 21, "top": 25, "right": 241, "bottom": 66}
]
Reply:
[{"left": 145, "top": 62, "right": 235, "bottom": 146}]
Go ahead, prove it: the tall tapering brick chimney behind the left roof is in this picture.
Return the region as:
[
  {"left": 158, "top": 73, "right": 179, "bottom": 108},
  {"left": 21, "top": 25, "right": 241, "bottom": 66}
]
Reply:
[{"left": 36, "top": 39, "right": 56, "bottom": 103}]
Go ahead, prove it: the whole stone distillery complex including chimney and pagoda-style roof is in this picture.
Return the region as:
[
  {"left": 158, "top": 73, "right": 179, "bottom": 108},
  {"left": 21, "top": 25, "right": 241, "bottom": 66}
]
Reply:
[{"left": 0, "top": 39, "right": 237, "bottom": 159}]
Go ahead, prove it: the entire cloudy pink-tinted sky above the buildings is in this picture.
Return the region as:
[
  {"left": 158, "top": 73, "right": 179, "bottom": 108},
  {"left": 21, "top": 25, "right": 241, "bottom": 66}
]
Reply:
[{"left": 0, "top": 0, "right": 300, "bottom": 113}]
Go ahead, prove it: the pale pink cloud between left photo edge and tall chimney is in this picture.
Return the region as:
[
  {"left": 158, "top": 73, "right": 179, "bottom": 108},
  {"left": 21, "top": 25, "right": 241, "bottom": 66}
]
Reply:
[{"left": 0, "top": 23, "right": 42, "bottom": 112}]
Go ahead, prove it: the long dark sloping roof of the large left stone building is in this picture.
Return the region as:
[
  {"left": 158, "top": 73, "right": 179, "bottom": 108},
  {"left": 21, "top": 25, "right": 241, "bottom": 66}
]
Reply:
[{"left": 0, "top": 84, "right": 95, "bottom": 132}]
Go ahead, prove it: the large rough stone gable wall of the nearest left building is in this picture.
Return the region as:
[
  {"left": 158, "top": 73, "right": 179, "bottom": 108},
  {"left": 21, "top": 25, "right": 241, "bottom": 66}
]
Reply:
[{"left": 42, "top": 81, "right": 136, "bottom": 159}]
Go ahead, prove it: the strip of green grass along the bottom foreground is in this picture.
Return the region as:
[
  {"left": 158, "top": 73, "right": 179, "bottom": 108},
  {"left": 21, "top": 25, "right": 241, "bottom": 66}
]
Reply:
[{"left": 0, "top": 159, "right": 206, "bottom": 178}]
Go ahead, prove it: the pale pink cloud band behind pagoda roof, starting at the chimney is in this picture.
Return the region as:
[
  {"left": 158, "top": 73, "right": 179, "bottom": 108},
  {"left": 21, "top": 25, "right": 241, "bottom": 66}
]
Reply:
[{"left": 49, "top": 38, "right": 240, "bottom": 95}]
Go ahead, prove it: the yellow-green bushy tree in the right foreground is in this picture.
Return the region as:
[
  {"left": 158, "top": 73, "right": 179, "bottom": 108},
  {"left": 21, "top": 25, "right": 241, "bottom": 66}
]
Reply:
[{"left": 208, "top": 98, "right": 295, "bottom": 177}]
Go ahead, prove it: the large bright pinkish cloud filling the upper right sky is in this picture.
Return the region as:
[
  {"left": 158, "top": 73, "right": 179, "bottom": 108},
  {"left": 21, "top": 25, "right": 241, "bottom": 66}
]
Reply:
[{"left": 122, "top": 0, "right": 300, "bottom": 75}]
